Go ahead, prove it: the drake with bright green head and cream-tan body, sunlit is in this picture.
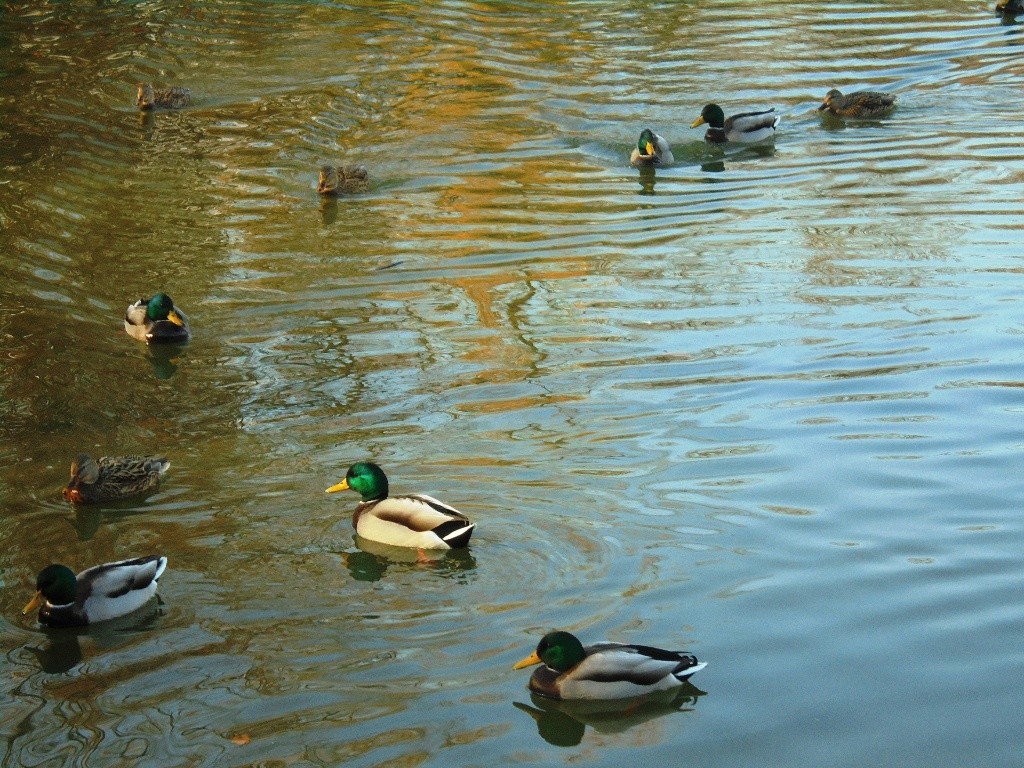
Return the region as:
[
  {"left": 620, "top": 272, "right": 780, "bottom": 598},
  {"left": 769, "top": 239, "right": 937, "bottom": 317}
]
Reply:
[{"left": 327, "top": 462, "right": 476, "bottom": 549}]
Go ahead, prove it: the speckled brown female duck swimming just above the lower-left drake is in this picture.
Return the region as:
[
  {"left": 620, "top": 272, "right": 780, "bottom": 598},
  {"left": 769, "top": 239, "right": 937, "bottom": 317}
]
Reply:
[{"left": 63, "top": 454, "right": 171, "bottom": 504}]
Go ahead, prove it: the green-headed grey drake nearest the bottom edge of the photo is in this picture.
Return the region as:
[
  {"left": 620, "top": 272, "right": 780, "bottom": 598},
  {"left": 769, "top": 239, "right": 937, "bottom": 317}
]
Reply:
[{"left": 513, "top": 632, "right": 707, "bottom": 699}]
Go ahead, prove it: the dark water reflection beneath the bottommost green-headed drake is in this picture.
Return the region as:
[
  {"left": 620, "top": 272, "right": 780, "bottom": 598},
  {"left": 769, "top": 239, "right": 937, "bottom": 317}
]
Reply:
[{"left": 512, "top": 683, "right": 706, "bottom": 746}]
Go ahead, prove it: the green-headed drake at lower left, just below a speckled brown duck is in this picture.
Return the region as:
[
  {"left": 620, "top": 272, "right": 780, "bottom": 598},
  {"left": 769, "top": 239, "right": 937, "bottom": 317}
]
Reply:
[{"left": 22, "top": 555, "right": 167, "bottom": 627}]
